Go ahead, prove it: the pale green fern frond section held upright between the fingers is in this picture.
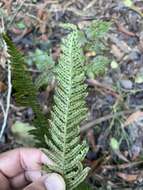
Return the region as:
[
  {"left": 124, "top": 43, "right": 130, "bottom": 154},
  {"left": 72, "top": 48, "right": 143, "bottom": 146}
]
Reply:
[{"left": 45, "top": 24, "right": 89, "bottom": 190}]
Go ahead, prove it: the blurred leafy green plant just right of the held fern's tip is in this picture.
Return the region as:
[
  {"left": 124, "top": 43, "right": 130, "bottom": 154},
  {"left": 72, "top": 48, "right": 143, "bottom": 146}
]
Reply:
[{"left": 82, "top": 20, "right": 112, "bottom": 78}]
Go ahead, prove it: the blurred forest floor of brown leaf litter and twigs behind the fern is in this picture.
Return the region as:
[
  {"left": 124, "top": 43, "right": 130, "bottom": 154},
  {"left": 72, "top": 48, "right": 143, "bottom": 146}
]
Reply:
[{"left": 0, "top": 0, "right": 143, "bottom": 190}]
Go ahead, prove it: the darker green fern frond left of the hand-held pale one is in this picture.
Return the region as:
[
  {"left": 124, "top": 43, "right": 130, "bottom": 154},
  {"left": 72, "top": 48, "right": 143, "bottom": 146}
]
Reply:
[{"left": 3, "top": 34, "right": 48, "bottom": 147}]
